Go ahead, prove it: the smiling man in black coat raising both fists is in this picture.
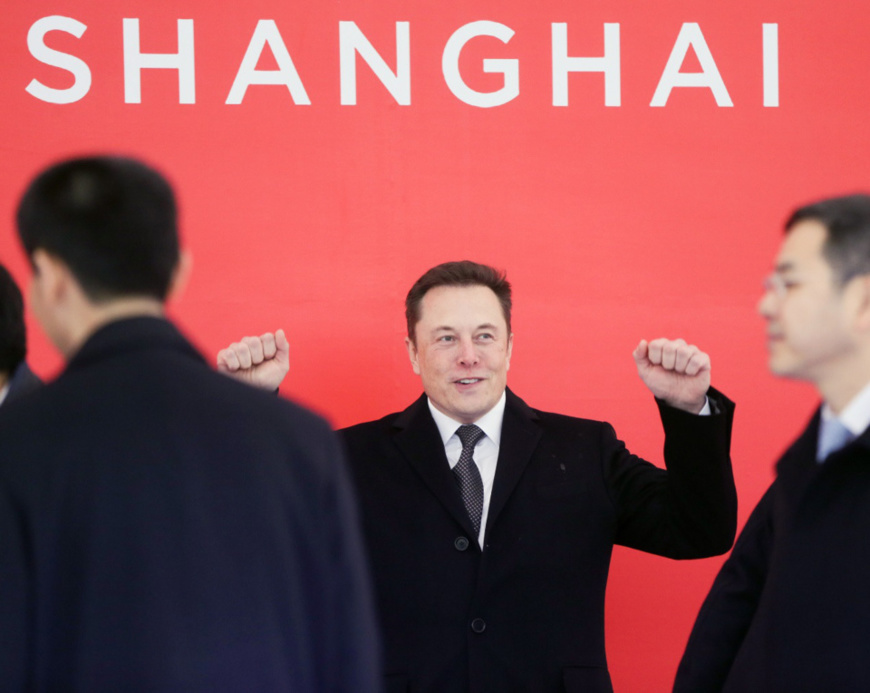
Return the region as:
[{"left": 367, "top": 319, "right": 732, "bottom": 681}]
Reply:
[{"left": 218, "top": 261, "right": 736, "bottom": 693}]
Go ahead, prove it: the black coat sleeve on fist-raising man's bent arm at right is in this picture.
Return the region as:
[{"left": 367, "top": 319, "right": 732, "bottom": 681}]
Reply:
[{"left": 604, "top": 390, "right": 737, "bottom": 558}]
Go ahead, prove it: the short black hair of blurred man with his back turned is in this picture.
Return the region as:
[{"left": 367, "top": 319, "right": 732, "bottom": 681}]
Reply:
[{"left": 17, "top": 156, "right": 179, "bottom": 303}]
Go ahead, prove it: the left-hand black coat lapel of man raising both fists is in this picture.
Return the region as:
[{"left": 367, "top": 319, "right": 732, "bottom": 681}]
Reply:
[{"left": 393, "top": 395, "right": 477, "bottom": 546}]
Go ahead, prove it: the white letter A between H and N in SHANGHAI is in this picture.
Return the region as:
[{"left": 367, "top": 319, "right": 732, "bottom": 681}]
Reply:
[{"left": 226, "top": 19, "right": 311, "bottom": 106}]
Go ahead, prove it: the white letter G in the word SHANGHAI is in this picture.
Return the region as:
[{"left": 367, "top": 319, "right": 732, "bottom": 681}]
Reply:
[{"left": 441, "top": 21, "right": 520, "bottom": 108}]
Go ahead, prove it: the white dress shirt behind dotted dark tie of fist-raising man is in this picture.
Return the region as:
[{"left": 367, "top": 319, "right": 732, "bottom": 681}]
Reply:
[{"left": 428, "top": 393, "right": 506, "bottom": 548}]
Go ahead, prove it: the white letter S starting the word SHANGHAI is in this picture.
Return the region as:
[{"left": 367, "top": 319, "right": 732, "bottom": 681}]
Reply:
[{"left": 25, "top": 15, "right": 91, "bottom": 104}]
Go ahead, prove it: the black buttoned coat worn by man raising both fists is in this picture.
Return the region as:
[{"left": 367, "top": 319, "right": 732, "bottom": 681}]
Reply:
[{"left": 341, "top": 391, "right": 736, "bottom": 693}]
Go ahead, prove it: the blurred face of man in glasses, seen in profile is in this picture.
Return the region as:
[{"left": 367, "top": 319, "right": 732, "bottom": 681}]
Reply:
[{"left": 758, "top": 220, "right": 857, "bottom": 385}]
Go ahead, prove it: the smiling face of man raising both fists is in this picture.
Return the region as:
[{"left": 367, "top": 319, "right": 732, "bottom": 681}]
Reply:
[{"left": 405, "top": 286, "right": 513, "bottom": 423}]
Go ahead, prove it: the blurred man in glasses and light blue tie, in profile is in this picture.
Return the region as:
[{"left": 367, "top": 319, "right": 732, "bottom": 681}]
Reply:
[{"left": 674, "top": 195, "right": 870, "bottom": 693}]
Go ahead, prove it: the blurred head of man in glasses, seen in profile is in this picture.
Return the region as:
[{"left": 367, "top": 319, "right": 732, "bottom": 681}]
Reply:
[{"left": 759, "top": 195, "right": 870, "bottom": 404}]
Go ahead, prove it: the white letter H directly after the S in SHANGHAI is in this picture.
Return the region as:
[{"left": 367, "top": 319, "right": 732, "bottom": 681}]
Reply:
[{"left": 124, "top": 18, "right": 196, "bottom": 103}]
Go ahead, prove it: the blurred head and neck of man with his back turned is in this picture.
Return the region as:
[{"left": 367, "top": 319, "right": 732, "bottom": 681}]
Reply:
[{"left": 17, "top": 156, "right": 179, "bottom": 354}]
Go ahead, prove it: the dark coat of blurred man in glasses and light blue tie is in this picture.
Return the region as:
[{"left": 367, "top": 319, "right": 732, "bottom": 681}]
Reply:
[{"left": 674, "top": 412, "right": 870, "bottom": 693}]
